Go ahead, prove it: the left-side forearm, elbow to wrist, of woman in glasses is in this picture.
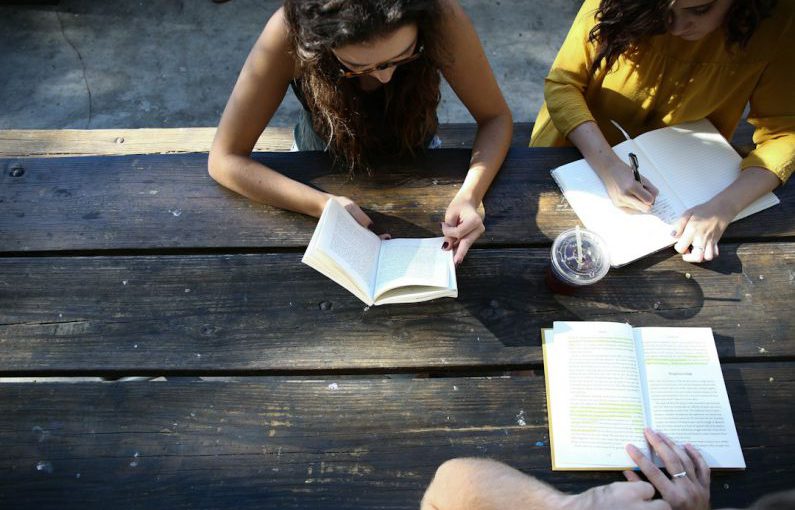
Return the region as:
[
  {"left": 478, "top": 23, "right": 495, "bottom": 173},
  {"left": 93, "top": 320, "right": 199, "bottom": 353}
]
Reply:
[{"left": 209, "top": 150, "right": 331, "bottom": 217}]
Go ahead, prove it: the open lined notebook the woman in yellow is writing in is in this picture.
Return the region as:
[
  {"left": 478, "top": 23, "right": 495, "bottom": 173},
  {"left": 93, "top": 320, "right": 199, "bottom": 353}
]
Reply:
[{"left": 552, "top": 119, "right": 779, "bottom": 267}]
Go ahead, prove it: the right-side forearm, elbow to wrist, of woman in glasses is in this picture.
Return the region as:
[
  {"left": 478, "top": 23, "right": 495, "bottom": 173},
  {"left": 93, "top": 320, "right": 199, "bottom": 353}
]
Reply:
[{"left": 456, "top": 113, "right": 513, "bottom": 204}]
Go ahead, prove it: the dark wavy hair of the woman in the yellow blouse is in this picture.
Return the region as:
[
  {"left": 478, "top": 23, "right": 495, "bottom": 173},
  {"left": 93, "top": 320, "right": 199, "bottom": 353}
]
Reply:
[{"left": 588, "top": 0, "right": 777, "bottom": 74}]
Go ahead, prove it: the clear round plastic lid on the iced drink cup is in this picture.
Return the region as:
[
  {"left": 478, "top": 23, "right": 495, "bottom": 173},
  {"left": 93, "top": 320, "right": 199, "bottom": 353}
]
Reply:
[{"left": 551, "top": 228, "right": 610, "bottom": 285}]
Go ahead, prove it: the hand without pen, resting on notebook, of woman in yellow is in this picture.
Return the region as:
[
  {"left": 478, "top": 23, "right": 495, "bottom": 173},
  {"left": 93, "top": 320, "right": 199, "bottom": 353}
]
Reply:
[{"left": 671, "top": 198, "right": 735, "bottom": 262}]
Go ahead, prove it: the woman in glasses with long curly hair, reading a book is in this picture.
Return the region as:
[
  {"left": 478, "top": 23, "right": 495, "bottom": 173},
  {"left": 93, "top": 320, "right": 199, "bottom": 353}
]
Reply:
[{"left": 208, "top": 0, "right": 512, "bottom": 263}]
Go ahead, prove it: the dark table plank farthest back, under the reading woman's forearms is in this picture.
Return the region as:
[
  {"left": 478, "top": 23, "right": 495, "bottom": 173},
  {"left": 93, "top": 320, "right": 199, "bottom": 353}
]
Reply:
[{"left": 0, "top": 149, "right": 795, "bottom": 252}]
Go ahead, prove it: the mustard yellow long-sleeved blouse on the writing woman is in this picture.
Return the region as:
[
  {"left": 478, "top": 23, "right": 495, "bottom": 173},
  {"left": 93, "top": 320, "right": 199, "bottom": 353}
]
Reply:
[{"left": 530, "top": 0, "right": 795, "bottom": 182}]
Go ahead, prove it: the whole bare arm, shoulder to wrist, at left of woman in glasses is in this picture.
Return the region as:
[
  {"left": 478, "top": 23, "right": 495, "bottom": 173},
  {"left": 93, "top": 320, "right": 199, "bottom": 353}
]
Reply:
[{"left": 208, "top": 9, "right": 330, "bottom": 217}]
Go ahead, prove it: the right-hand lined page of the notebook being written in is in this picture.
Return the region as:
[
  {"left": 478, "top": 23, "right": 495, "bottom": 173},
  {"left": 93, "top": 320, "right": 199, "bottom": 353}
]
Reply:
[{"left": 635, "top": 119, "right": 779, "bottom": 220}]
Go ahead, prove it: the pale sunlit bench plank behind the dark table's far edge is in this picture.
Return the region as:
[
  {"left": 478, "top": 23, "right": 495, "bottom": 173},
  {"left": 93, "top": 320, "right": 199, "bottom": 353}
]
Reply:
[{"left": 0, "top": 122, "right": 753, "bottom": 158}]
